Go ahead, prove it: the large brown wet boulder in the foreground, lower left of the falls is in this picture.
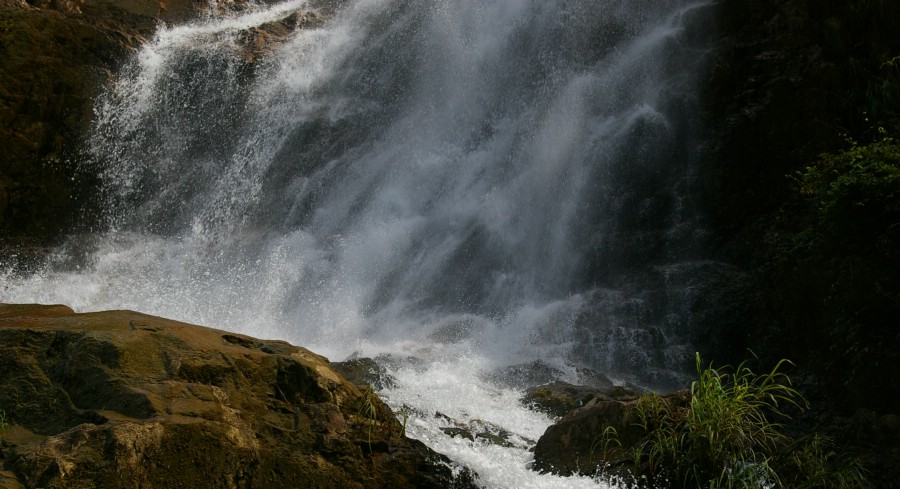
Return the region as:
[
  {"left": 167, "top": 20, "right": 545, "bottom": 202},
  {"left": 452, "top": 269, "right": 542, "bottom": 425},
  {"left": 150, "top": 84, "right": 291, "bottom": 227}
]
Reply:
[{"left": 0, "top": 305, "right": 471, "bottom": 488}]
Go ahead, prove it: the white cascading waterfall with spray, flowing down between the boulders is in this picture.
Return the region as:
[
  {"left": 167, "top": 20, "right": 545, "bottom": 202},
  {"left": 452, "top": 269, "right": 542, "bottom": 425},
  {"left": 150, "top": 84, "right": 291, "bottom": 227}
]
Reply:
[{"left": 0, "top": 0, "right": 716, "bottom": 487}]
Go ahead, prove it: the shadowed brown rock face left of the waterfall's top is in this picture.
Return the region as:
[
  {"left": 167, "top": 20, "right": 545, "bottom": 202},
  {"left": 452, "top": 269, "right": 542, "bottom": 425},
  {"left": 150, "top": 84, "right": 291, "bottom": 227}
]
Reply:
[{"left": 0, "top": 2, "right": 148, "bottom": 248}]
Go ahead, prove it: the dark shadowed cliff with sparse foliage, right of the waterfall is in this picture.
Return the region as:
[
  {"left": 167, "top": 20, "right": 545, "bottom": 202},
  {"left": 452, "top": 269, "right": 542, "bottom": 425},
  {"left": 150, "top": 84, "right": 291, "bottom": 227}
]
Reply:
[{"left": 701, "top": 0, "right": 900, "bottom": 487}]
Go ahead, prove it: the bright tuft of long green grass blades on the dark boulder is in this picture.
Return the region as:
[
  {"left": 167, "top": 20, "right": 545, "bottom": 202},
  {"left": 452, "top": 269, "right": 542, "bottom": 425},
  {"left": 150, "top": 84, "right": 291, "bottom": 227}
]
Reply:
[{"left": 624, "top": 355, "right": 800, "bottom": 487}]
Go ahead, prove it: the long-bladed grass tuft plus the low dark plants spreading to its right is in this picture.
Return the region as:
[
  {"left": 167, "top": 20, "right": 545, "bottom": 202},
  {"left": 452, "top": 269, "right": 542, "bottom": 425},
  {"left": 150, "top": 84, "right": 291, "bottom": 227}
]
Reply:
[{"left": 603, "top": 355, "right": 862, "bottom": 489}]
